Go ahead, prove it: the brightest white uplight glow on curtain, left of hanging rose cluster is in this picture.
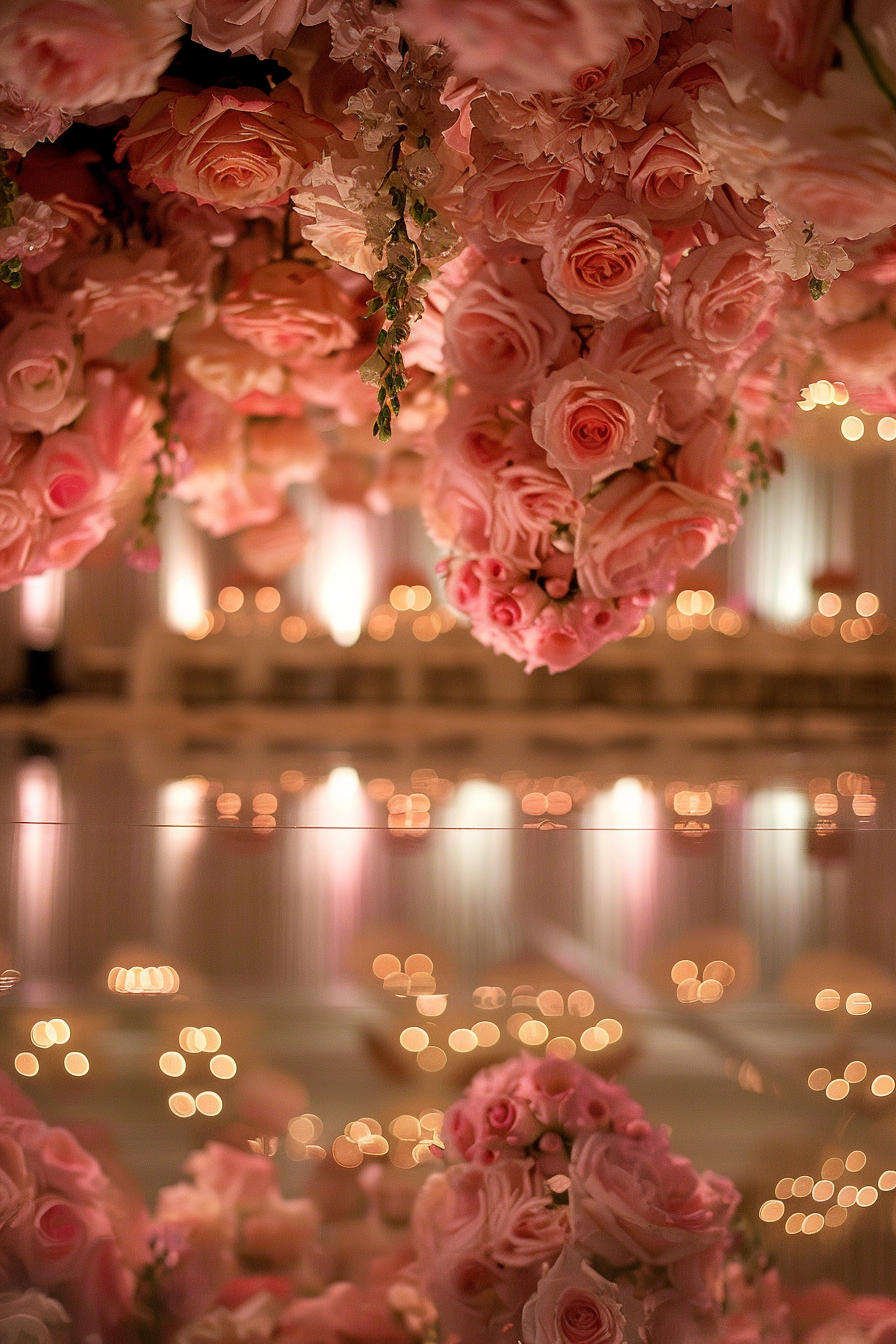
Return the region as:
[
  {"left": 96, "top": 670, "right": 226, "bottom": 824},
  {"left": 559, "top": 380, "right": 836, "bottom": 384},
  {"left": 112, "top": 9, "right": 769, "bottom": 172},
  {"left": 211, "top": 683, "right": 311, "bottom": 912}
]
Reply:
[{"left": 314, "top": 505, "right": 371, "bottom": 648}]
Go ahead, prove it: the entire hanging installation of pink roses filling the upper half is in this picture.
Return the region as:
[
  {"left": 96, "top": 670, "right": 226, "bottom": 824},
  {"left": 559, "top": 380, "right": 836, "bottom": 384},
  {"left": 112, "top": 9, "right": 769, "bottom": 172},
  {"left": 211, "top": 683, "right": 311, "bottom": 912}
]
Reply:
[{"left": 0, "top": 0, "right": 896, "bottom": 671}]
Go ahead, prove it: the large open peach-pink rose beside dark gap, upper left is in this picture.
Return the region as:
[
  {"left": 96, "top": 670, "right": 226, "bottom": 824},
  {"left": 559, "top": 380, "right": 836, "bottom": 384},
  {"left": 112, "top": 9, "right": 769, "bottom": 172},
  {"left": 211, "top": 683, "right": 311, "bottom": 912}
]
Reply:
[{"left": 116, "top": 83, "right": 332, "bottom": 210}]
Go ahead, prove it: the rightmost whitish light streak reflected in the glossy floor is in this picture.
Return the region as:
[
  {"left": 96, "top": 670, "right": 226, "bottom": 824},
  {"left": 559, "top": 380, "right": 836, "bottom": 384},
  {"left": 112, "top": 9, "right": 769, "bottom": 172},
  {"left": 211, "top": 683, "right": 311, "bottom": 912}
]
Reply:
[{"left": 743, "top": 789, "right": 821, "bottom": 980}]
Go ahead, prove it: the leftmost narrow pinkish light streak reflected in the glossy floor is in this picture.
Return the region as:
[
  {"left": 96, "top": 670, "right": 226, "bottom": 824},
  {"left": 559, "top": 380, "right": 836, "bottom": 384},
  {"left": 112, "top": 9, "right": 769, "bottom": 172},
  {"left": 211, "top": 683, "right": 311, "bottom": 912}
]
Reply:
[{"left": 15, "top": 757, "right": 62, "bottom": 988}]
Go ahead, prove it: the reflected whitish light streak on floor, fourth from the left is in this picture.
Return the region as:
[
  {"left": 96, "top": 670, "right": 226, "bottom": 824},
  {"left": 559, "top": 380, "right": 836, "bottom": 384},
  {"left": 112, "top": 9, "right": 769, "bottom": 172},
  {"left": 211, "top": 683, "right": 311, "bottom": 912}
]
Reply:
[{"left": 429, "top": 780, "right": 519, "bottom": 976}]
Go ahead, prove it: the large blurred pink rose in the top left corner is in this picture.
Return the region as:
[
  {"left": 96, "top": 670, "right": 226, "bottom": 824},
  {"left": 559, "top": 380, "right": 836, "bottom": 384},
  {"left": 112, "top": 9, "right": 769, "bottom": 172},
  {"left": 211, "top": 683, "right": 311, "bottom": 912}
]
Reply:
[{"left": 0, "top": 0, "right": 184, "bottom": 112}]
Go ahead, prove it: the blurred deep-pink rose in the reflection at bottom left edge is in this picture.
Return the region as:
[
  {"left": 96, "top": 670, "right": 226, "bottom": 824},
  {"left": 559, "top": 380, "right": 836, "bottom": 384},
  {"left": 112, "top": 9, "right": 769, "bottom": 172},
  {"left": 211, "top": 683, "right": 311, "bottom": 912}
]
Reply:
[{"left": 4, "top": 1195, "right": 111, "bottom": 1288}]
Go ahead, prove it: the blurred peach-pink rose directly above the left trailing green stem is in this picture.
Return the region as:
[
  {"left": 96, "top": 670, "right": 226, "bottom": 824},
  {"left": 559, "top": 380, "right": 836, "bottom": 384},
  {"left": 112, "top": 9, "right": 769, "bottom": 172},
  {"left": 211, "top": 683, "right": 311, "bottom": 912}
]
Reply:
[{"left": 64, "top": 247, "right": 193, "bottom": 359}]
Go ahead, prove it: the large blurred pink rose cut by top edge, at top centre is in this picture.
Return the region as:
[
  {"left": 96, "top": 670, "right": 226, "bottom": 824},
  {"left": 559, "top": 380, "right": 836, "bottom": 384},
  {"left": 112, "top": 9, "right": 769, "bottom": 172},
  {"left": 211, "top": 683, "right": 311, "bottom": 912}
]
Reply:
[{"left": 402, "top": 0, "right": 645, "bottom": 94}]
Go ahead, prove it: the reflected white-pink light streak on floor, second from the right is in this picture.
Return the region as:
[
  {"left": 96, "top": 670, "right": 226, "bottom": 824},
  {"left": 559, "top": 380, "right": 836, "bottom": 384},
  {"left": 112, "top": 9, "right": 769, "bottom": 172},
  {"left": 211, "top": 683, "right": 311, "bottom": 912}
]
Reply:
[{"left": 582, "top": 778, "right": 658, "bottom": 970}]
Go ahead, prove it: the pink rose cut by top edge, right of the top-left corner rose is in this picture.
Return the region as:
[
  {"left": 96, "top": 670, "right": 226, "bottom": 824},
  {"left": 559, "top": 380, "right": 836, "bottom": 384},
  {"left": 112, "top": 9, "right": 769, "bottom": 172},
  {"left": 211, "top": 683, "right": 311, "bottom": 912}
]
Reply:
[{"left": 177, "top": 0, "right": 336, "bottom": 56}]
